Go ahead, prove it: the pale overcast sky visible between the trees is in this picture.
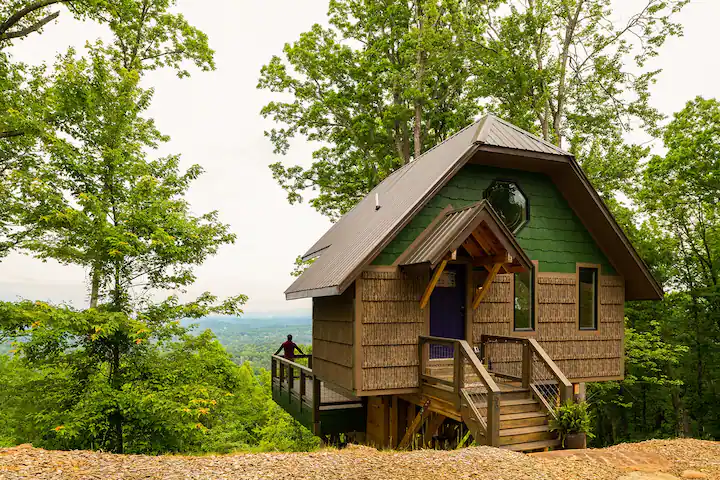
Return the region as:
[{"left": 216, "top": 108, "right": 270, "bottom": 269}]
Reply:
[{"left": 0, "top": 0, "right": 720, "bottom": 313}]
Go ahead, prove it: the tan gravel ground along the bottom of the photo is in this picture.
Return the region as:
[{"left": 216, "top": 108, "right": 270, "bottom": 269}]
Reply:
[{"left": 0, "top": 440, "right": 720, "bottom": 480}]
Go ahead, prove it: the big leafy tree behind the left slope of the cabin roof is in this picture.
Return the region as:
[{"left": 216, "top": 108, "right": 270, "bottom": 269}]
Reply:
[{"left": 258, "top": 0, "right": 484, "bottom": 219}]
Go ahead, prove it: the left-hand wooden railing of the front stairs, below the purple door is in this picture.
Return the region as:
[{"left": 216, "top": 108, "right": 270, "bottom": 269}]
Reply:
[{"left": 418, "top": 335, "right": 500, "bottom": 446}]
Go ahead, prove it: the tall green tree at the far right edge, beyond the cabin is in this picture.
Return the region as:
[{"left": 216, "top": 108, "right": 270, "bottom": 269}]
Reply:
[{"left": 638, "top": 97, "right": 720, "bottom": 436}]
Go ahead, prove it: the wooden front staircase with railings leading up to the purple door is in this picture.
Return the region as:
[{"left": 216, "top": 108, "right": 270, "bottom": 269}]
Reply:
[{"left": 420, "top": 337, "right": 572, "bottom": 452}]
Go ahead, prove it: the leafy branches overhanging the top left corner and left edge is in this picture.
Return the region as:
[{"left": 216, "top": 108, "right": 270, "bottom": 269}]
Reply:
[{"left": 0, "top": 0, "right": 214, "bottom": 257}]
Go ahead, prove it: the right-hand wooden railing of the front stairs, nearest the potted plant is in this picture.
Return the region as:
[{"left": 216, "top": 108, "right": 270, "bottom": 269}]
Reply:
[{"left": 479, "top": 335, "right": 572, "bottom": 416}]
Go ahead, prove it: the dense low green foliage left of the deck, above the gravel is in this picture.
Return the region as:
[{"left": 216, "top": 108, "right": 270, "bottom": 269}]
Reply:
[{"left": 0, "top": 302, "right": 318, "bottom": 453}]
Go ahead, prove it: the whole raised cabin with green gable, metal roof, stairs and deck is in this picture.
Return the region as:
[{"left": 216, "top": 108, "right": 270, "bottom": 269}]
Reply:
[{"left": 272, "top": 115, "right": 662, "bottom": 451}]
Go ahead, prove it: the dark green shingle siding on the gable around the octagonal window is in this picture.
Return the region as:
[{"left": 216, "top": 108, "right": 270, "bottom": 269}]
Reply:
[{"left": 373, "top": 165, "right": 615, "bottom": 274}]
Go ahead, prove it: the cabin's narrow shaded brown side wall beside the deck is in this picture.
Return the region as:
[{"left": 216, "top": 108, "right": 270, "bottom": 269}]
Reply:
[{"left": 312, "top": 288, "right": 354, "bottom": 390}]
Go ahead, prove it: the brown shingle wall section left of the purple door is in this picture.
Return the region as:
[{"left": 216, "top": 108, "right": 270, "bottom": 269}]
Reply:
[{"left": 360, "top": 269, "right": 428, "bottom": 390}]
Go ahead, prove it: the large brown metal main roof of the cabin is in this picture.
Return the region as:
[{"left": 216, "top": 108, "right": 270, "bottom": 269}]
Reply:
[{"left": 285, "top": 115, "right": 661, "bottom": 299}]
